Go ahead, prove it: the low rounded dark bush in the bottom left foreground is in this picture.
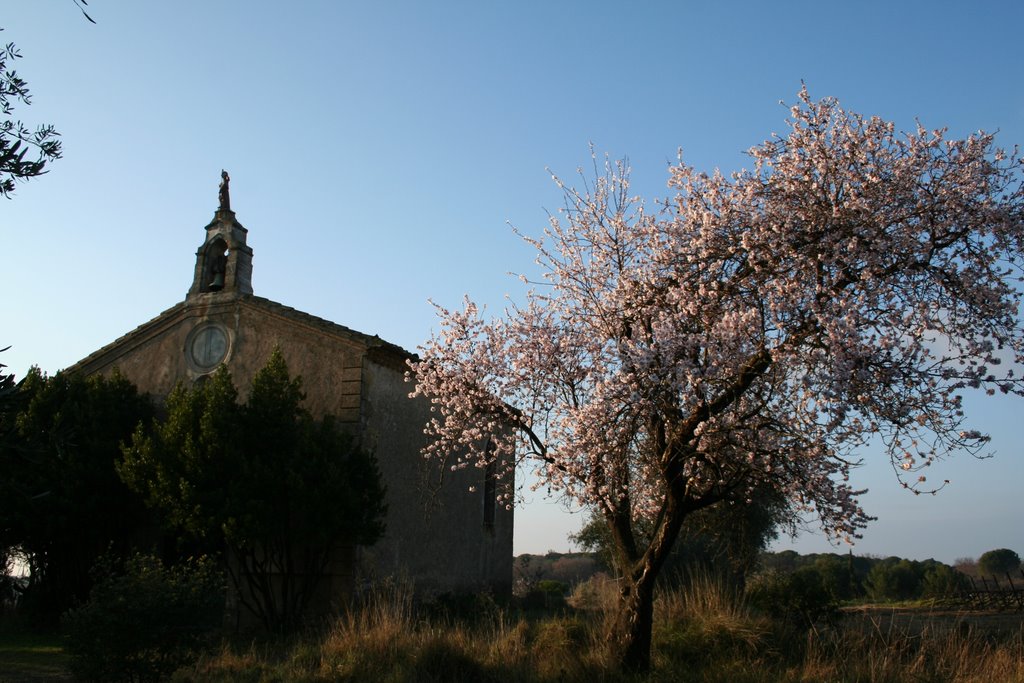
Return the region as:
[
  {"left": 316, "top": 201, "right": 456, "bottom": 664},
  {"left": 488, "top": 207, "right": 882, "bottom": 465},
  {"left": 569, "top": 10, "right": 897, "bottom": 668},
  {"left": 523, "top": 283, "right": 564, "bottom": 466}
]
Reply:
[{"left": 62, "top": 555, "right": 224, "bottom": 682}]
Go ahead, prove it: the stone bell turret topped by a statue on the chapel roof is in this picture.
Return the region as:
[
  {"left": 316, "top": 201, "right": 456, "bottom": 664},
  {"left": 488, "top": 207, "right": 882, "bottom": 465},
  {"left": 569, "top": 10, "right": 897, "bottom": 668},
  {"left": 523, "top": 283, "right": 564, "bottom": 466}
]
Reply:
[{"left": 186, "top": 170, "right": 253, "bottom": 299}]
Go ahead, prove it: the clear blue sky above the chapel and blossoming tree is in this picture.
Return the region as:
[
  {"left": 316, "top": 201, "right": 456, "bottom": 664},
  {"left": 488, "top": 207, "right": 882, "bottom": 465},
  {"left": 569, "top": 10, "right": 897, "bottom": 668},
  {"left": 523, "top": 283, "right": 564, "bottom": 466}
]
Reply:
[{"left": 0, "top": 0, "right": 1024, "bottom": 561}]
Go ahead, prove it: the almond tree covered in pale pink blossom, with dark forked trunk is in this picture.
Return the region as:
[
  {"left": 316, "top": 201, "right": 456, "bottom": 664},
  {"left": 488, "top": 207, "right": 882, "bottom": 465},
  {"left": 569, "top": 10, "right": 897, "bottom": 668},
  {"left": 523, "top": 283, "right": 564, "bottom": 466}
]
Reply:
[{"left": 411, "top": 89, "right": 1024, "bottom": 670}]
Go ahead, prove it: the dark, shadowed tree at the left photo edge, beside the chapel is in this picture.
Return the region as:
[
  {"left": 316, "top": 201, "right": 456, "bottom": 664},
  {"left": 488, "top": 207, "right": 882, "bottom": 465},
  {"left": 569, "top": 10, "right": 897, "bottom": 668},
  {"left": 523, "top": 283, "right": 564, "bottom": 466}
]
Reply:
[{"left": 0, "top": 369, "right": 153, "bottom": 623}]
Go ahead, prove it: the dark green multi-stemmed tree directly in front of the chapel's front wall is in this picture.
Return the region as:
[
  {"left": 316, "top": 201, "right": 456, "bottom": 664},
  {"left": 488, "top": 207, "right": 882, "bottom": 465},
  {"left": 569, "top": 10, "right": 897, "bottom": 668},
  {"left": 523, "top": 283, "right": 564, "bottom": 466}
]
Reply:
[{"left": 119, "top": 350, "right": 385, "bottom": 631}]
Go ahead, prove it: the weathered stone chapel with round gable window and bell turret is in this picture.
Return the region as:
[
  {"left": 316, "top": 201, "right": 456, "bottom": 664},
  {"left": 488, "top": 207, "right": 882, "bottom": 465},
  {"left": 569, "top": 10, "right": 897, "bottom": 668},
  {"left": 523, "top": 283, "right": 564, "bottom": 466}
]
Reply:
[{"left": 72, "top": 200, "right": 513, "bottom": 594}]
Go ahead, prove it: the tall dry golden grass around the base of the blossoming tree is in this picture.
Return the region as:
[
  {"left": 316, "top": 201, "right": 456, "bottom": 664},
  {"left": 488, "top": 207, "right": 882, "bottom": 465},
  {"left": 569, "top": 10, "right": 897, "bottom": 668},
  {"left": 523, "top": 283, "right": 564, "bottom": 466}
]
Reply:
[{"left": 174, "top": 575, "right": 1024, "bottom": 683}]
